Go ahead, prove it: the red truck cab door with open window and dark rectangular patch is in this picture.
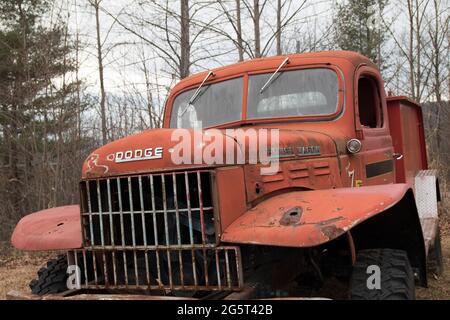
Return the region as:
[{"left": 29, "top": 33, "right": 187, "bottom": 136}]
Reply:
[{"left": 355, "top": 66, "right": 395, "bottom": 186}]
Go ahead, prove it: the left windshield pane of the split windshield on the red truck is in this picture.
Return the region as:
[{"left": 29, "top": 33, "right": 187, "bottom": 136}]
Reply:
[{"left": 170, "top": 77, "right": 243, "bottom": 129}]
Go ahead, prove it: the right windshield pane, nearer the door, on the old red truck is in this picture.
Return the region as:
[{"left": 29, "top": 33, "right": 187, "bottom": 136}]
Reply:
[{"left": 247, "top": 69, "right": 338, "bottom": 119}]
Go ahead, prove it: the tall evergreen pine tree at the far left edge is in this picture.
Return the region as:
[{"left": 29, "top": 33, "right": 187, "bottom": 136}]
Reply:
[{"left": 0, "top": 0, "right": 82, "bottom": 220}]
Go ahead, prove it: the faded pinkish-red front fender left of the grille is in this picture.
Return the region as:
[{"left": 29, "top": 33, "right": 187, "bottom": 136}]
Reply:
[{"left": 11, "top": 205, "right": 82, "bottom": 251}]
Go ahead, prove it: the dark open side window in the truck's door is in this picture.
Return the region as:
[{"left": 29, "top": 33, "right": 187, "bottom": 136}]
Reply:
[{"left": 358, "top": 76, "right": 383, "bottom": 128}]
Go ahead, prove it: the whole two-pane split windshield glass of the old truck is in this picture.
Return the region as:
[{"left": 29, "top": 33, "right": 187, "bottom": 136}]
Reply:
[{"left": 170, "top": 68, "right": 339, "bottom": 129}]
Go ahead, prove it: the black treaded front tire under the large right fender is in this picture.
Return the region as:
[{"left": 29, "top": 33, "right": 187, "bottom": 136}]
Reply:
[{"left": 350, "top": 249, "right": 415, "bottom": 300}]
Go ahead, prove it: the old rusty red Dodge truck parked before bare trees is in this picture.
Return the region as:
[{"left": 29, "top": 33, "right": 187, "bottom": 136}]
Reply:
[{"left": 10, "top": 52, "right": 442, "bottom": 299}]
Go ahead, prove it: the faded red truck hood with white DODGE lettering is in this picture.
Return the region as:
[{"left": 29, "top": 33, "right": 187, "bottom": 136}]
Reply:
[{"left": 82, "top": 128, "right": 337, "bottom": 179}]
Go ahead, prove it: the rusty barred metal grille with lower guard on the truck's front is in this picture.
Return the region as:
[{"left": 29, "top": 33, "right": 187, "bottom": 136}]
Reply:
[{"left": 74, "top": 171, "right": 242, "bottom": 290}]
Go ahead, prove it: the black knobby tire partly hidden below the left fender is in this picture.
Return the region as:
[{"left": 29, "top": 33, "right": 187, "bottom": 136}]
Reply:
[{"left": 30, "top": 256, "right": 68, "bottom": 296}]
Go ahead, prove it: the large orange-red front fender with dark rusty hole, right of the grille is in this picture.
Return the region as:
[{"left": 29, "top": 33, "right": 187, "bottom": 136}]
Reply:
[{"left": 222, "top": 184, "right": 408, "bottom": 247}]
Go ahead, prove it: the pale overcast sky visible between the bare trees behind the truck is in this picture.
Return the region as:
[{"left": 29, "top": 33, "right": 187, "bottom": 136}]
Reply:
[{"left": 48, "top": 0, "right": 440, "bottom": 102}]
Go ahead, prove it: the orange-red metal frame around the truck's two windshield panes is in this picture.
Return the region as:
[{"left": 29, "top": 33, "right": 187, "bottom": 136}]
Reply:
[{"left": 163, "top": 64, "right": 346, "bottom": 129}]
